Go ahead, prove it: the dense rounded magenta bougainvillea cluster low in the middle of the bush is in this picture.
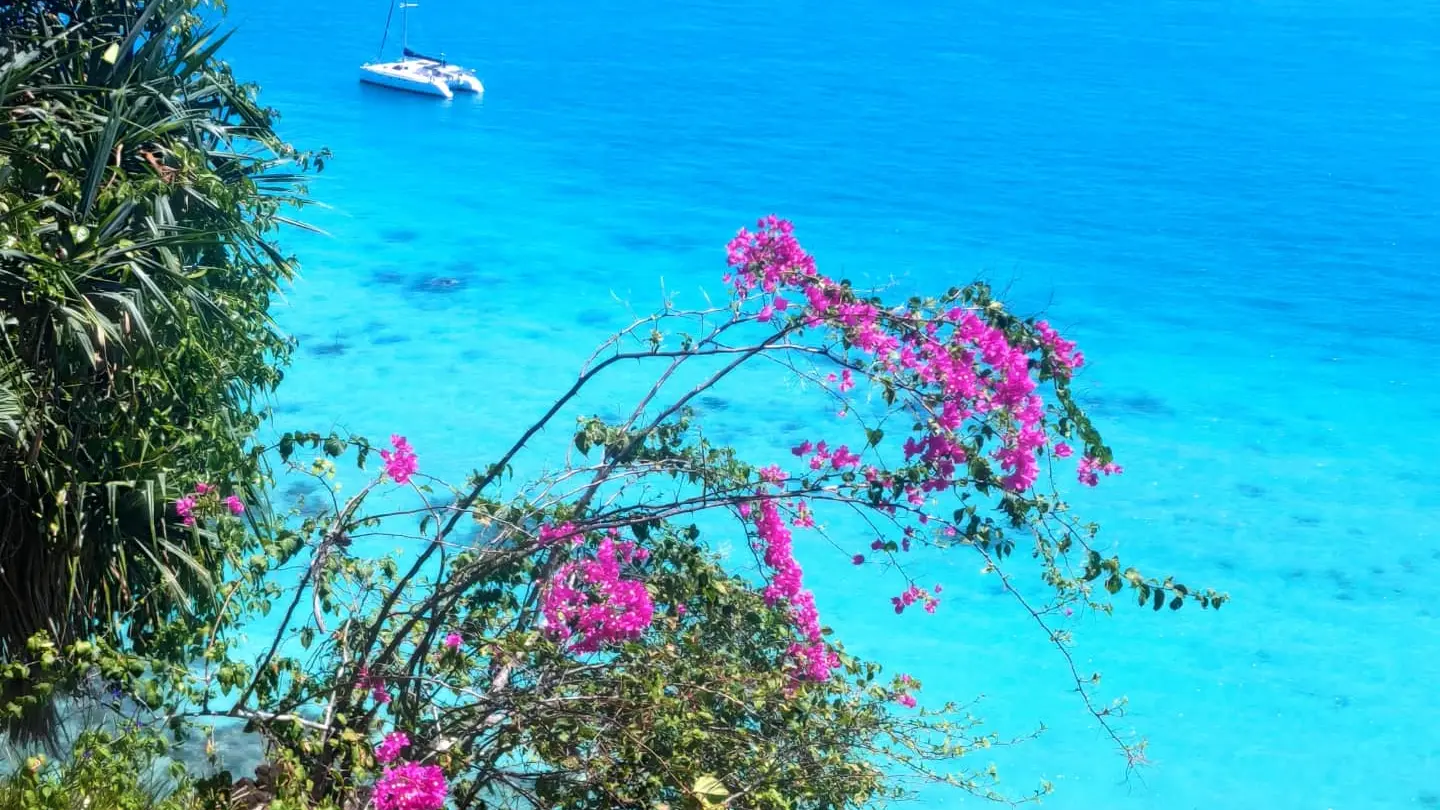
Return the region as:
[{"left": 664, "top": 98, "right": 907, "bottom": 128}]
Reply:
[{"left": 540, "top": 523, "right": 655, "bottom": 653}]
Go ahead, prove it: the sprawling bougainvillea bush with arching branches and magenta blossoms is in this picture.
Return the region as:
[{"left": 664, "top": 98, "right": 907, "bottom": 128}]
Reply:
[{"left": 0, "top": 218, "right": 1225, "bottom": 810}]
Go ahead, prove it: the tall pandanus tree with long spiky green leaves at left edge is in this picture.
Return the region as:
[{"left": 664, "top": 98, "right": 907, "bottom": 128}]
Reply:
[{"left": 0, "top": 0, "right": 323, "bottom": 735}]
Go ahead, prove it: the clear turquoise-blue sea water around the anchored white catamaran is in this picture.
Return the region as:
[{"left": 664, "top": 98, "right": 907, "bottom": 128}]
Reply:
[{"left": 218, "top": 0, "right": 1440, "bottom": 810}]
